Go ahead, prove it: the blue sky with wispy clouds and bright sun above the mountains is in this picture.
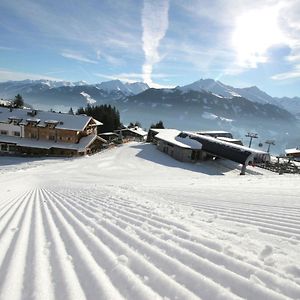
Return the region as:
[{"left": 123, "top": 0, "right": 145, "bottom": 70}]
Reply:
[{"left": 0, "top": 0, "right": 300, "bottom": 96}]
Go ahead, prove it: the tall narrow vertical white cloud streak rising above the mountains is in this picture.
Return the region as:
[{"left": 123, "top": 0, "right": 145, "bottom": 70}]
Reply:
[{"left": 142, "top": 0, "right": 169, "bottom": 85}]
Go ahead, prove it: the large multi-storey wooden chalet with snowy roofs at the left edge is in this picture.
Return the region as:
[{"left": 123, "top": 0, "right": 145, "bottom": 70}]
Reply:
[{"left": 0, "top": 107, "right": 106, "bottom": 156}]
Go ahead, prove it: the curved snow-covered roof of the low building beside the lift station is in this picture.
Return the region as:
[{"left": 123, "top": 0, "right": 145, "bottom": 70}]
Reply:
[{"left": 155, "top": 129, "right": 202, "bottom": 149}]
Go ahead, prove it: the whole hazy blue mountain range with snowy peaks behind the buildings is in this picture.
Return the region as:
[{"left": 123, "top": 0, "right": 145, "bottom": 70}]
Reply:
[{"left": 0, "top": 79, "right": 300, "bottom": 152}]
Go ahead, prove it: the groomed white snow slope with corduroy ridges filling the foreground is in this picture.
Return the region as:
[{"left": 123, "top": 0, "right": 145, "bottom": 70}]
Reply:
[{"left": 0, "top": 143, "right": 300, "bottom": 300}]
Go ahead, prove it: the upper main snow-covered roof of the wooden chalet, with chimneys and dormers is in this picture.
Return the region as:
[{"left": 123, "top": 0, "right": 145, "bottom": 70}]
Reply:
[{"left": 0, "top": 107, "right": 102, "bottom": 131}]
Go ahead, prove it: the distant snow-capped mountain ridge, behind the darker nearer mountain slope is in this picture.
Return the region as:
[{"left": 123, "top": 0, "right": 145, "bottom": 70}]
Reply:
[{"left": 0, "top": 79, "right": 300, "bottom": 117}]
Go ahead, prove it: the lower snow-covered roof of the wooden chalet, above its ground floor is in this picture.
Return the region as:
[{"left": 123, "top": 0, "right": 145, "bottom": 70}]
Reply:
[{"left": 0, "top": 134, "right": 106, "bottom": 152}]
